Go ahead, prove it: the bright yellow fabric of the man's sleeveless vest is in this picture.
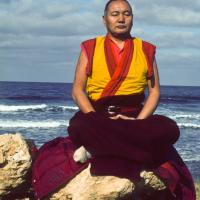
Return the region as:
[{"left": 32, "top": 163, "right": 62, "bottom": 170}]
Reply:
[{"left": 86, "top": 37, "right": 148, "bottom": 100}]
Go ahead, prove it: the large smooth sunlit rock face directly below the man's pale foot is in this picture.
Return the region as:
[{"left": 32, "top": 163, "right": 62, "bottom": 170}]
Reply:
[{"left": 48, "top": 166, "right": 134, "bottom": 200}]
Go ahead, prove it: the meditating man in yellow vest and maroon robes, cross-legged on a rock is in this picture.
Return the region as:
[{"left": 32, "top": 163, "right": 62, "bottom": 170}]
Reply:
[{"left": 33, "top": 0, "right": 195, "bottom": 200}]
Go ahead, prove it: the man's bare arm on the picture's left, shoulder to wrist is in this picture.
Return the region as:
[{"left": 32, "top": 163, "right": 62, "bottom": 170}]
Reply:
[{"left": 72, "top": 51, "right": 94, "bottom": 113}]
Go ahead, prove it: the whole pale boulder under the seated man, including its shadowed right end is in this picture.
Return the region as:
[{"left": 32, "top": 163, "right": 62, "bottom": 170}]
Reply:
[{"left": 46, "top": 165, "right": 166, "bottom": 200}]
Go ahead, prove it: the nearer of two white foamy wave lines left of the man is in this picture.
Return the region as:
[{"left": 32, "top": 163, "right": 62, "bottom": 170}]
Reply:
[{"left": 0, "top": 120, "right": 69, "bottom": 128}]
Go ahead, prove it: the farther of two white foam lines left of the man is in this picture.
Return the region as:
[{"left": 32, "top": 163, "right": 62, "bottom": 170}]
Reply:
[{"left": 0, "top": 104, "right": 47, "bottom": 112}]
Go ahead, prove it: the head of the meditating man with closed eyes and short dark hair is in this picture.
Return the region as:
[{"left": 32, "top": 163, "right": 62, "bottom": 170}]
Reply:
[{"left": 103, "top": 1, "right": 133, "bottom": 36}]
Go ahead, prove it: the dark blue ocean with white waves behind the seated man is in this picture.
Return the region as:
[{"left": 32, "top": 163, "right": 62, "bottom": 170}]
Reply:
[{"left": 0, "top": 82, "right": 200, "bottom": 179}]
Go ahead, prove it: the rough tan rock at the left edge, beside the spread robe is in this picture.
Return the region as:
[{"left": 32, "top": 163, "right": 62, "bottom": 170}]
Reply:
[{"left": 0, "top": 133, "right": 32, "bottom": 199}]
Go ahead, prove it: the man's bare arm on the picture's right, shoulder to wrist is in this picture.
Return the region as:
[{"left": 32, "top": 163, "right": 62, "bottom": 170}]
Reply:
[{"left": 137, "top": 60, "right": 160, "bottom": 119}]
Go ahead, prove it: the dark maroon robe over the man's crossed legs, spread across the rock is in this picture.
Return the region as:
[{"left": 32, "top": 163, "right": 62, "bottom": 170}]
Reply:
[{"left": 32, "top": 37, "right": 195, "bottom": 200}]
